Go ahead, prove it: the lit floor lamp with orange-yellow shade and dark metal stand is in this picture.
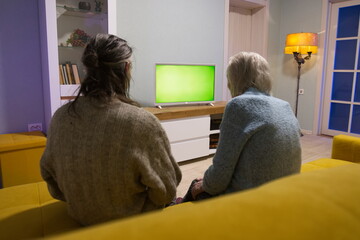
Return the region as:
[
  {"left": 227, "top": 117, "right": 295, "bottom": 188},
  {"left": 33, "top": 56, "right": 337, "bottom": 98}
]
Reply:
[{"left": 284, "top": 33, "right": 318, "bottom": 117}]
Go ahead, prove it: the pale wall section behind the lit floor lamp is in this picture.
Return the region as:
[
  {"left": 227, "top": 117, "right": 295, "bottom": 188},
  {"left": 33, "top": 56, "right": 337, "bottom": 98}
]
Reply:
[{"left": 268, "top": 0, "right": 322, "bottom": 131}]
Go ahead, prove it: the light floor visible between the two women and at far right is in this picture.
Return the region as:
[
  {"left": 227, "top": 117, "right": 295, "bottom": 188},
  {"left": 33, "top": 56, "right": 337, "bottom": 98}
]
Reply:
[{"left": 177, "top": 134, "right": 332, "bottom": 197}]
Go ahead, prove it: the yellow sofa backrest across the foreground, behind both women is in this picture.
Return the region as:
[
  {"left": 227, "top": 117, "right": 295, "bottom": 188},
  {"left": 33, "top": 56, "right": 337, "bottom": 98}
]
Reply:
[{"left": 47, "top": 164, "right": 360, "bottom": 240}]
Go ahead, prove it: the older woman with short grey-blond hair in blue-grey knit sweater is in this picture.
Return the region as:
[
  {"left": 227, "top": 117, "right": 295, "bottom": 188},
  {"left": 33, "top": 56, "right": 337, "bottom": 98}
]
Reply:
[{"left": 182, "top": 52, "right": 301, "bottom": 202}]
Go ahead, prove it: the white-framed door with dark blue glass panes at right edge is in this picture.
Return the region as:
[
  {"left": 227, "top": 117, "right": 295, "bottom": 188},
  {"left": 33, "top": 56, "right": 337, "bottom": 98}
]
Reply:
[{"left": 321, "top": 0, "right": 360, "bottom": 136}]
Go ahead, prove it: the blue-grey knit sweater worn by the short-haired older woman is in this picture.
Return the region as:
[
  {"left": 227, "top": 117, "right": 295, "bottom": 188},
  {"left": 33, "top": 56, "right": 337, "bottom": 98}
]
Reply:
[{"left": 203, "top": 88, "right": 301, "bottom": 195}]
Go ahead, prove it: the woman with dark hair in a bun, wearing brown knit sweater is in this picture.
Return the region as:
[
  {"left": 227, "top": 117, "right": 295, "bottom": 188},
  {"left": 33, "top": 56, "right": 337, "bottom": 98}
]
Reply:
[{"left": 40, "top": 34, "right": 181, "bottom": 225}]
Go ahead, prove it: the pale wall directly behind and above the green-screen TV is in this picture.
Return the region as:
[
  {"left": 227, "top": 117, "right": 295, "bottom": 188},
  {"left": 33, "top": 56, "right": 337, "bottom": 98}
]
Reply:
[{"left": 117, "top": 0, "right": 225, "bottom": 106}]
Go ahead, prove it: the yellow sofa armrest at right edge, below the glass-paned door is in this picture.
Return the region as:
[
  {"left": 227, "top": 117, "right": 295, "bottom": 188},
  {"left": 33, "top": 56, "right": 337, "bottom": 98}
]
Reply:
[{"left": 331, "top": 135, "right": 360, "bottom": 162}]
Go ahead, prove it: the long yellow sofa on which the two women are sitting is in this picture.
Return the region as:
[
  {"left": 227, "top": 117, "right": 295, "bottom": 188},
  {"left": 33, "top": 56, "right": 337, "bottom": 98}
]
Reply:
[{"left": 0, "top": 136, "right": 360, "bottom": 240}]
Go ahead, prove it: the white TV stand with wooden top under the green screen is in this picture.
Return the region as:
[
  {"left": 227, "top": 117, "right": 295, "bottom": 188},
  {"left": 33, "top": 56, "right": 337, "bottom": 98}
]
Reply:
[{"left": 144, "top": 102, "right": 226, "bottom": 162}]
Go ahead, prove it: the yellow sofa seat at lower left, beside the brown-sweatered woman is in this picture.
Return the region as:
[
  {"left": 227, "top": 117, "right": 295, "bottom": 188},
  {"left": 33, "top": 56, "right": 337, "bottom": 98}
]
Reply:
[{"left": 0, "top": 182, "right": 81, "bottom": 239}]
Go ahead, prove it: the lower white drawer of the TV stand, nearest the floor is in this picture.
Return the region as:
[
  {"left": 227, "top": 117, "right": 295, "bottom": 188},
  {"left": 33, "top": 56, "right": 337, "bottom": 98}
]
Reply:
[{"left": 171, "top": 137, "right": 209, "bottom": 162}]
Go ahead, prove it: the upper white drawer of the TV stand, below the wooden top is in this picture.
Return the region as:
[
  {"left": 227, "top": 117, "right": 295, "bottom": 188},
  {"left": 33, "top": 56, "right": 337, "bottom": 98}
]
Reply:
[{"left": 161, "top": 116, "right": 210, "bottom": 144}]
